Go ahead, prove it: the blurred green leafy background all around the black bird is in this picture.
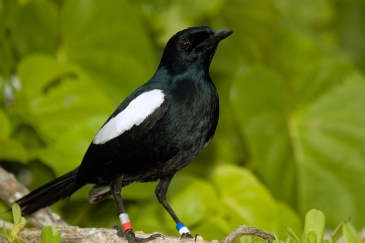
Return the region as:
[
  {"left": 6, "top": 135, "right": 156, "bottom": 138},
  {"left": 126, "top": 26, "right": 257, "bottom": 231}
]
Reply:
[{"left": 0, "top": 0, "right": 365, "bottom": 240}]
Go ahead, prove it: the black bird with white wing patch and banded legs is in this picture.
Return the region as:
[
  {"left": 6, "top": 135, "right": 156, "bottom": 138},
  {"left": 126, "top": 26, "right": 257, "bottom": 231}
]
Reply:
[{"left": 16, "top": 26, "right": 233, "bottom": 242}]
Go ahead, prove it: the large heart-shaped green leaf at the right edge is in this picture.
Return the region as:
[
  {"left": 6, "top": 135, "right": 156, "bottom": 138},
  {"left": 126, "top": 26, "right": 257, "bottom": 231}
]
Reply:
[{"left": 232, "top": 60, "right": 365, "bottom": 227}]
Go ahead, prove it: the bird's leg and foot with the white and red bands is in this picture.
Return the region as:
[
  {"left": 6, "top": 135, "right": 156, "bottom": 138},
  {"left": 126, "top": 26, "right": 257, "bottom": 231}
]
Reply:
[{"left": 111, "top": 176, "right": 162, "bottom": 243}]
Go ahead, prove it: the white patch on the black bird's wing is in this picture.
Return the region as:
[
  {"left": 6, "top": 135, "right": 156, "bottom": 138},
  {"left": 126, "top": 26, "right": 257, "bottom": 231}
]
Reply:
[{"left": 93, "top": 89, "right": 165, "bottom": 144}]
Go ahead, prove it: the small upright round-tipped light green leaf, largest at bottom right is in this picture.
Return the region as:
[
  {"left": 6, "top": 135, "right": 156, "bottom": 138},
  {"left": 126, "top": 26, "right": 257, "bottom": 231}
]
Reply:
[{"left": 304, "top": 209, "right": 325, "bottom": 243}]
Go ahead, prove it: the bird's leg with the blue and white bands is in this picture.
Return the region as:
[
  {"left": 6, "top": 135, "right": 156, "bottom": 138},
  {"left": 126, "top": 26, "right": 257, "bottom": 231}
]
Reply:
[{"left": 155, "top": 175, "right": 193, "bottom": 238}]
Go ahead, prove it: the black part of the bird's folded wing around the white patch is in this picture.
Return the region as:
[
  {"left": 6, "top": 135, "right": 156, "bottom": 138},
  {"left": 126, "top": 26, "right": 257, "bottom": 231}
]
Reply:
[{"left": 77, "top": 92, "right": 171, "bottom": 186}]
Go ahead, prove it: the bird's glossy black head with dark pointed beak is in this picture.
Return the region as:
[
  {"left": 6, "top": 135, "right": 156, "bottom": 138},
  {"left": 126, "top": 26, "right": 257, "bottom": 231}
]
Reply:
[{"left": 160, "top": 26, "right": 233, "bottom": 72}]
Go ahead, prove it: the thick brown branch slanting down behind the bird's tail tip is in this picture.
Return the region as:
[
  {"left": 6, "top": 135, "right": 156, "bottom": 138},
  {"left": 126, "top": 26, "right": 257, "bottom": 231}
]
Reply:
[{"left": 0, "top": 167, "right": 67, "bottom": 228}]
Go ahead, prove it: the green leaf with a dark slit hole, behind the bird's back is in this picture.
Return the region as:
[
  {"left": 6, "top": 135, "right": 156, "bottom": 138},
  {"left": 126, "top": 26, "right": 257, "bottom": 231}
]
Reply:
[{"left": 18, "top": 55, "right": 115, "bottom": 141}]
